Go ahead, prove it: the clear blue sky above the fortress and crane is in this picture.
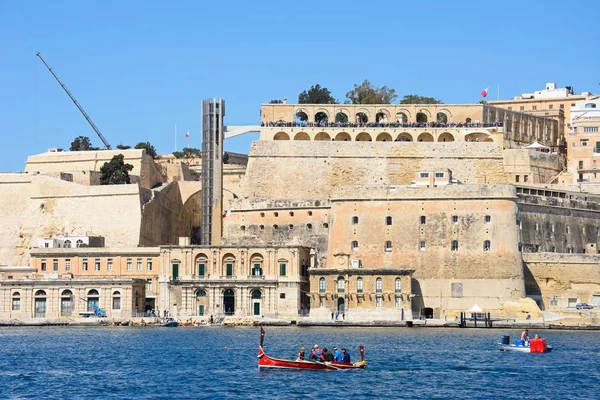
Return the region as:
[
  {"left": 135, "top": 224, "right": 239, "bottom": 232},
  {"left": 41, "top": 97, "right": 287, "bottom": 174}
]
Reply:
[{"left": 0, "top": 0, "right": 600, "bottom": 171}]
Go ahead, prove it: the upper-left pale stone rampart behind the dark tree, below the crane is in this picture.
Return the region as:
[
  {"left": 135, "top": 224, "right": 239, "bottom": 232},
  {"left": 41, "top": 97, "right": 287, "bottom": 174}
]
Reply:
[{"left": 25, "top": 149, "right": 162, "bottom": 188}]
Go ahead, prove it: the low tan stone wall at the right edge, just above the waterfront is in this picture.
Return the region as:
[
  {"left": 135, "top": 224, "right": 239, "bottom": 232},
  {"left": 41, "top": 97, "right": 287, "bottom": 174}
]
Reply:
[{"left": 523, "top": 253, "right": 600, "bottom": 310}]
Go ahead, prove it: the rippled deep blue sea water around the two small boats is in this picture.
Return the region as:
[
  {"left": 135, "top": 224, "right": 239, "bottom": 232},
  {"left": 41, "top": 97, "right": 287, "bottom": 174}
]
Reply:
[{"left": 0, "top": 327, "right": 600, "bottom": 399}]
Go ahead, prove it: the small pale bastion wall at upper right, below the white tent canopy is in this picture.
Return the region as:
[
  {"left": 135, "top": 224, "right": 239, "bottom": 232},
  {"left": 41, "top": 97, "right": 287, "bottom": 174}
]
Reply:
[{"left": 502, "top": 149, "right": 564, "bottom": 184}]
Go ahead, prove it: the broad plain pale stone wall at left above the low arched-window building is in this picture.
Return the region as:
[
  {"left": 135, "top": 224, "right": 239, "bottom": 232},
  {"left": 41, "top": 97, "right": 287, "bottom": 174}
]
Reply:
[{"left": 0, "top": 174, "right": 143, "bottom": 265}]
